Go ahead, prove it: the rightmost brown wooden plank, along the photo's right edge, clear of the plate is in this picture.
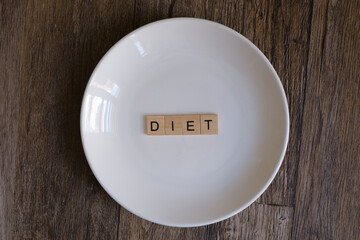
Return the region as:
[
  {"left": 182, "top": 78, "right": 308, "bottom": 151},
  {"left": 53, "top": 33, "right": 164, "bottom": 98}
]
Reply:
[{"left": 292, "top": 1, "right": 360, "bottom": 239}]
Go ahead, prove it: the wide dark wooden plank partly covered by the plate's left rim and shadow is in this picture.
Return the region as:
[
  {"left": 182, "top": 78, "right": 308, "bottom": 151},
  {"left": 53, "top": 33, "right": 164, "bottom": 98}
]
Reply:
[{"left": 11, "top": 1, "right": 134, "bottom": 239}]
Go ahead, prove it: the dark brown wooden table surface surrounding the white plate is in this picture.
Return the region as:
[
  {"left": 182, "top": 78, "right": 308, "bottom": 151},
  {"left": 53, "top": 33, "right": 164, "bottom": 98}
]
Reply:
[{"left": 0, "top": 0, "right": 360, "bottom": 239}]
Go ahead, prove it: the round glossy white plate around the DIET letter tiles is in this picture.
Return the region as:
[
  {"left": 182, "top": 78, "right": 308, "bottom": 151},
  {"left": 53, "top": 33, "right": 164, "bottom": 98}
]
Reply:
[{"left": 81, "top": 18, "right": 289, "bottom": 226}]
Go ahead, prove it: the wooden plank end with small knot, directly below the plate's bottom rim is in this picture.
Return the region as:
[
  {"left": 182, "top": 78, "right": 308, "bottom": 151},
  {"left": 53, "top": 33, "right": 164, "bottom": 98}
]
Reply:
[{"left": 119, "top": 203, "right": 293, "bottom": 240}]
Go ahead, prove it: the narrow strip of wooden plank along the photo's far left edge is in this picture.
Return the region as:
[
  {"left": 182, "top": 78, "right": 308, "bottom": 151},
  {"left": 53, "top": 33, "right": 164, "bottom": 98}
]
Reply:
[{"left": 0, "top": 1, "right": 26, "bottom": 239}]
